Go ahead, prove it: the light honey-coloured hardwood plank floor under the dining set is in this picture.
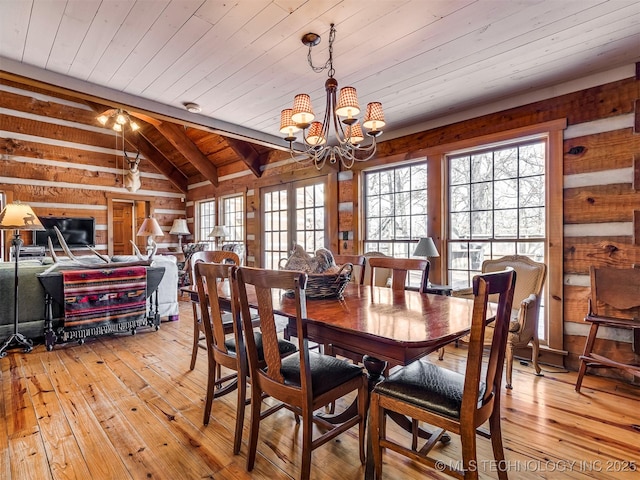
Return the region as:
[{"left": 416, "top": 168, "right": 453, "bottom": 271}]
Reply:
[{"left": 0, "top": 301, "right": 640, "bottom": 480}]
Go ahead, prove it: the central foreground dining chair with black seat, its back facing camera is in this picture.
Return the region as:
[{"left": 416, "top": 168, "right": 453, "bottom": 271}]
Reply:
[{"left": 234, "top": 267, "right": 368, "bottom": 479}]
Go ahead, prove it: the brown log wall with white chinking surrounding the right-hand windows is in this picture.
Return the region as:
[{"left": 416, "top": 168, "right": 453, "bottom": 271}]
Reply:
[{"left": 187, "top": 65, "right": 640, "bottom": 379}]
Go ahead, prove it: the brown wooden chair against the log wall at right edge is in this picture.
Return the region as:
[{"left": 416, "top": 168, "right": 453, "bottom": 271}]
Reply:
[{"left": 576, "top": 266, "right": 640, "bottom": 392}]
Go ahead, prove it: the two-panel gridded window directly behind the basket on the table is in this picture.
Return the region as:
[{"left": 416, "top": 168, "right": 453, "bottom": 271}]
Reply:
[{"left": 262, "top": 179, "right": 327, "bottom": 269}]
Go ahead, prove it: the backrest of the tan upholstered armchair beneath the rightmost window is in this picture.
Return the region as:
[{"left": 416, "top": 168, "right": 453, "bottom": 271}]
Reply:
[{"left": 482, "top": 255, "right": 547, "bottom": 310}]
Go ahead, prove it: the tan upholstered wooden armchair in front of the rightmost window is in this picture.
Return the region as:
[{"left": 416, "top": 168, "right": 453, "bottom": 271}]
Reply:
[{"left": 455, "top": 255, "right": 547, "bottom": 389}]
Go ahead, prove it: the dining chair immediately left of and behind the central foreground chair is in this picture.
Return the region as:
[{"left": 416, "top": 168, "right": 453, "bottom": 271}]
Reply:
[{"left": 194, "top": 262, "right": 296, "bottom": 455}]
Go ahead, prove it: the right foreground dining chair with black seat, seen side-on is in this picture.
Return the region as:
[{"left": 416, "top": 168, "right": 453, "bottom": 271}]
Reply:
[{"left": 370, "top": 270, "right": 516, "bottom": 480}]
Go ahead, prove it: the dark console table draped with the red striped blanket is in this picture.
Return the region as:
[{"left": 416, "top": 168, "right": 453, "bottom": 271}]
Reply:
[{"left": 38, "top": 264, "right": 165, "bottom": 351}]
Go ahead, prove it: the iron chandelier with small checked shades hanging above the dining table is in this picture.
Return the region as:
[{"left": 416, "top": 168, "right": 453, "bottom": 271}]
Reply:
[{"left": 280, "top": 23, "right": 385, "bottom": 170}]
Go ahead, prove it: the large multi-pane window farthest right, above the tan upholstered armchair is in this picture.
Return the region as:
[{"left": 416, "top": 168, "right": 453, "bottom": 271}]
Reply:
[{"left": 448, "top": 141, "right": 546, "bottom": 289}]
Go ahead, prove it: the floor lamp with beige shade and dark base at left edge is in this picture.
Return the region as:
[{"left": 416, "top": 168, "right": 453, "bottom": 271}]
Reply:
[{"left": 0, "top": 202, "right": 45, "bottom": 358}]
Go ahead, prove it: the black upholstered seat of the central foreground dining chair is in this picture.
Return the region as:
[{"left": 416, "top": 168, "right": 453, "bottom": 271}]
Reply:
[{"left": 280, "top": 352, "right": 362, "bottom": 397}]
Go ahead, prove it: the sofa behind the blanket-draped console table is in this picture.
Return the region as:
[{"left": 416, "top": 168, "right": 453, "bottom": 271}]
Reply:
[{"left": 0, "top": 255, "right": 179, "bottom": 342}]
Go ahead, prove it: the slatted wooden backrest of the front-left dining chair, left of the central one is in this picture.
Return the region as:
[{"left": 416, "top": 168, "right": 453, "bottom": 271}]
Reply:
[{"left": 194, "top": 261, "right": 245, "bottom": 365}]
